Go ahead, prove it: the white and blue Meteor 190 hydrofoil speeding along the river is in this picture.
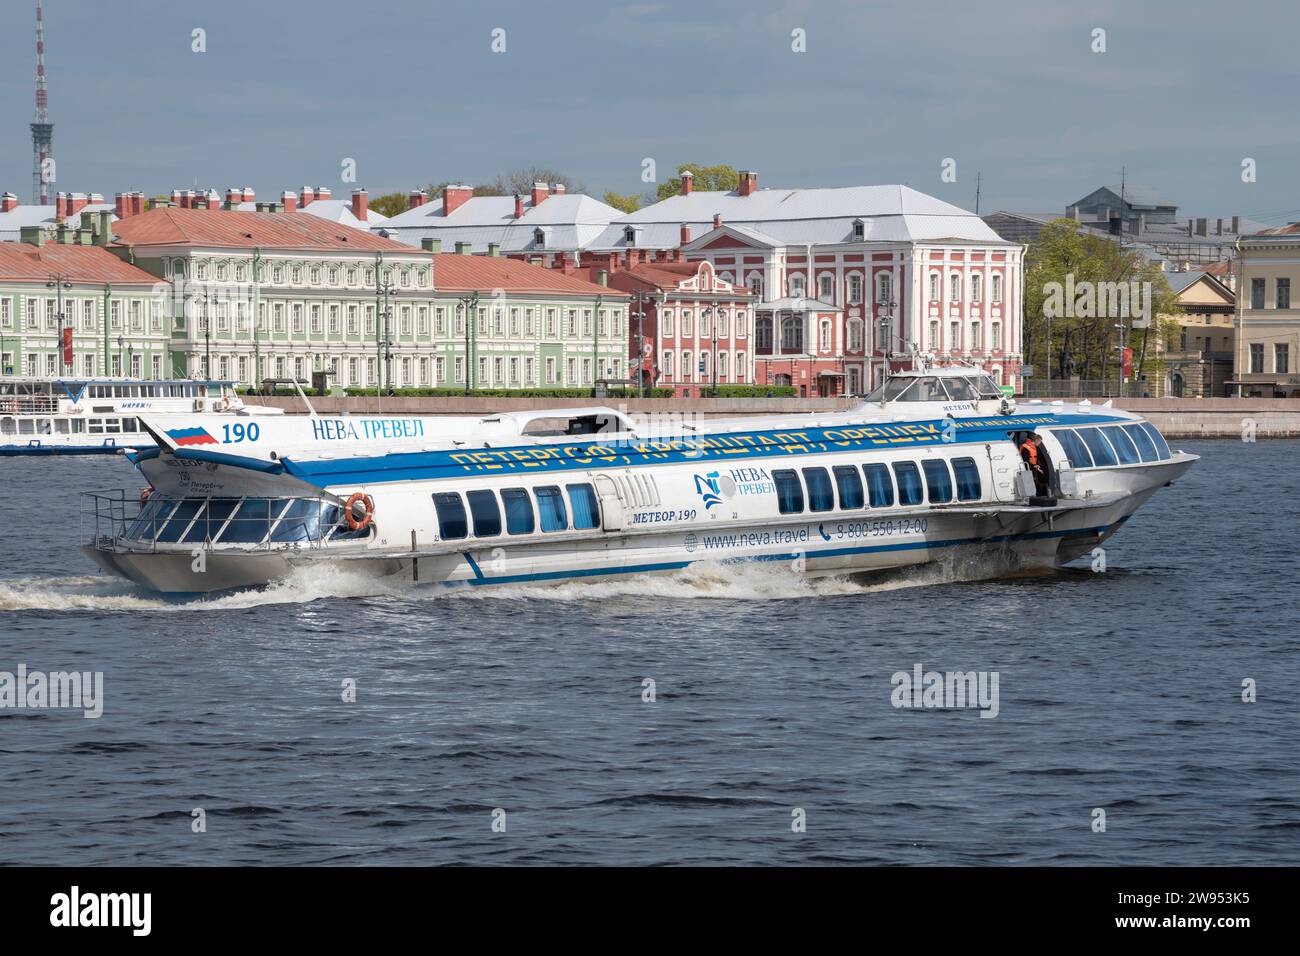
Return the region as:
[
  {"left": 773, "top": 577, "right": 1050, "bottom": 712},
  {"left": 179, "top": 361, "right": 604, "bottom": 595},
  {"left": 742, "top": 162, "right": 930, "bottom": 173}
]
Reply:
[{"left": 82, "top": 392, "right": 1196, "bottom": 593}]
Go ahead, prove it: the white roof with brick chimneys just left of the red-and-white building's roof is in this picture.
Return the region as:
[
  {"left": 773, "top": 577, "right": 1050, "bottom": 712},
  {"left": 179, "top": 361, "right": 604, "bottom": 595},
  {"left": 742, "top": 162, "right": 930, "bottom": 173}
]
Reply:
[{"left": 374, "top": 193, "right": 623, "bottom": 252}]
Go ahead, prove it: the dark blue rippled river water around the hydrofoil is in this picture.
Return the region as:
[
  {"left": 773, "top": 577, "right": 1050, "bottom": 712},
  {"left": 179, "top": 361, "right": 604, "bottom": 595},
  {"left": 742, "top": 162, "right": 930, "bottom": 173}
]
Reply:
[{"left": 0, "top": 441, "right": 1300, "bottom": 864}]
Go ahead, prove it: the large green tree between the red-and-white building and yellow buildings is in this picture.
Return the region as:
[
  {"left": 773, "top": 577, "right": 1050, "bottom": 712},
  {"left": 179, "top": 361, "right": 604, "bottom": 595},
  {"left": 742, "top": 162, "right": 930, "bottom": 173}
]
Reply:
[{"left": 1023, "top": 219, "right": 1178, "bottom": 390}]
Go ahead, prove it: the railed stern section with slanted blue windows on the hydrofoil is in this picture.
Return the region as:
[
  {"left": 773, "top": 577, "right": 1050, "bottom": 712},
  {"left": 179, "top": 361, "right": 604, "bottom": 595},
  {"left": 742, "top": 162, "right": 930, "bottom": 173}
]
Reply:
[{"left": 81, "top": 489, "right": 369, "bottom": 551}]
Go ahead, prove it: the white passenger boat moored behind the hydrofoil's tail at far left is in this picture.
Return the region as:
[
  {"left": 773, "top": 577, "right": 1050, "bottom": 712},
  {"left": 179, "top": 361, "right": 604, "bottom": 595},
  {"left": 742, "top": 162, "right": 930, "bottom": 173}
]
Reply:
[{"left": 0, "top": 378, "right": 283, "bottom": 455}]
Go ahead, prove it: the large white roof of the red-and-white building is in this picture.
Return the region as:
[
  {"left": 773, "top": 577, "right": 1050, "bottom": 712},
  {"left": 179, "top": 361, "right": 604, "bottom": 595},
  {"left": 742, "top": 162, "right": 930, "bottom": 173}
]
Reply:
[{"left": 590, "top": 186, "right": 1014, "bottom": 250}]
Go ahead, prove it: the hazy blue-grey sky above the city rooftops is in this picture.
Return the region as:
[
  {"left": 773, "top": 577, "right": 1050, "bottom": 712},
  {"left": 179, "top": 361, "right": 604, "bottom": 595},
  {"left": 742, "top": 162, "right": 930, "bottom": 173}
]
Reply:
[{"left": 0, "top": 0, "right": 1300, "bottom": 222}]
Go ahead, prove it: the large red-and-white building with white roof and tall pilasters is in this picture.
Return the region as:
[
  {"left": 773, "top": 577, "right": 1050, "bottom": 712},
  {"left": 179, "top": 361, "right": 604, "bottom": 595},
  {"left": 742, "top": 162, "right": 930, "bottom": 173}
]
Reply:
[{"left": 584, "top": 172, "right": 1023, "bottom": 395}]
